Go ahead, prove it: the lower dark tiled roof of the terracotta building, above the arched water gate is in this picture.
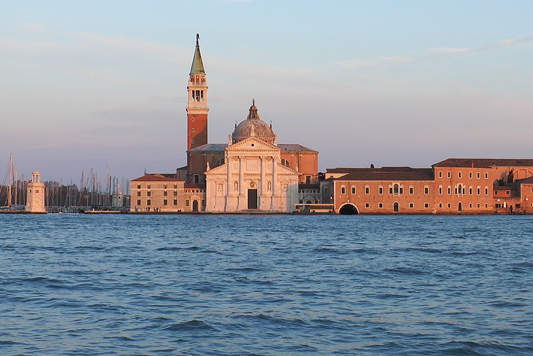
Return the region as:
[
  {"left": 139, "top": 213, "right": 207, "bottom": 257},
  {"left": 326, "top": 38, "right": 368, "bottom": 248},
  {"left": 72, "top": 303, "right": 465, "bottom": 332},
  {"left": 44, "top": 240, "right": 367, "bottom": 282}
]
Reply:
[{"left": 335, "top": 167, "right": 433, "bottom": 181}]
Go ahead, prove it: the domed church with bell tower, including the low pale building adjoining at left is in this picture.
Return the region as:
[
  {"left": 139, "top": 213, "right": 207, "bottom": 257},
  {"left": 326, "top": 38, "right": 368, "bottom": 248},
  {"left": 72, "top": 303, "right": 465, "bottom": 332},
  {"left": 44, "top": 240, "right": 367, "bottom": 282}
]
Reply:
[{"left": 130, "top": 35, "right": 319, "bottom": 213}]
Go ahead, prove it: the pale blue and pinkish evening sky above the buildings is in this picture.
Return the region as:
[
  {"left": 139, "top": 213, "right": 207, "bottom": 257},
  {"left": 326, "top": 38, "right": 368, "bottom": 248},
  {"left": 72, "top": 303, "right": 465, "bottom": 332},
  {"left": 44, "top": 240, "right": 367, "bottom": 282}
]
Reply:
[{"left": 0, "top": 0, "right": 533, "bottom": 184}]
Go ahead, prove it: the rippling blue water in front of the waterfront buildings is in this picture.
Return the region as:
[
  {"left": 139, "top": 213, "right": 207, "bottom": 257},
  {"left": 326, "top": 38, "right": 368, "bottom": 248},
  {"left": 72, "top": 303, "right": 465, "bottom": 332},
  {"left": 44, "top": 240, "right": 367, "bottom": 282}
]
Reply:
[{"left": 0, "top": 214, "right": 533, "bottom": 355}]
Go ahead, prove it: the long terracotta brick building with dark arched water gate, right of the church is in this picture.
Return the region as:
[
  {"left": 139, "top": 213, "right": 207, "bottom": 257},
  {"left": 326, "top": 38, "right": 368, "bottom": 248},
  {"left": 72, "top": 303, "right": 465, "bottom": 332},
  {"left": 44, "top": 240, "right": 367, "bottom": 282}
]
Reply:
[{"left": 328, "top": 158, "right": 533, "bottom": 214}]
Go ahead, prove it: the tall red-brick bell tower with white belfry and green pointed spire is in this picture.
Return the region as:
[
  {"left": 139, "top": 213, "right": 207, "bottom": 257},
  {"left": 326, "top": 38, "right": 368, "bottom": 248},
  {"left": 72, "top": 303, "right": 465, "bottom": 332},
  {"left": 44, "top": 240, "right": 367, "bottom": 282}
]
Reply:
[{"left": 186, "top": 34, "right": 209, "bottom": 150}]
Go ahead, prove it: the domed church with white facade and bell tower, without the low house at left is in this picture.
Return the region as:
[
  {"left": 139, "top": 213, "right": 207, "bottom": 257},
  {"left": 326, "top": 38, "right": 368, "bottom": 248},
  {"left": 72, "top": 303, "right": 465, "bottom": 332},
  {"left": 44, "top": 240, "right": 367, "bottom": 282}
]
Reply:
[{"left": 178, "top": 36, "right": 318, "bottom": 213}]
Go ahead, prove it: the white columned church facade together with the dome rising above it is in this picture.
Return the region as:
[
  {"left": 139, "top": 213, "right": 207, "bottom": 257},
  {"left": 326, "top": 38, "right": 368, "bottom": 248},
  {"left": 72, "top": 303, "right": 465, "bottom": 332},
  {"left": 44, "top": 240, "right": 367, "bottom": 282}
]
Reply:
[{"left": 205, "top": 104, "right": 298, "bottom": 213}]
